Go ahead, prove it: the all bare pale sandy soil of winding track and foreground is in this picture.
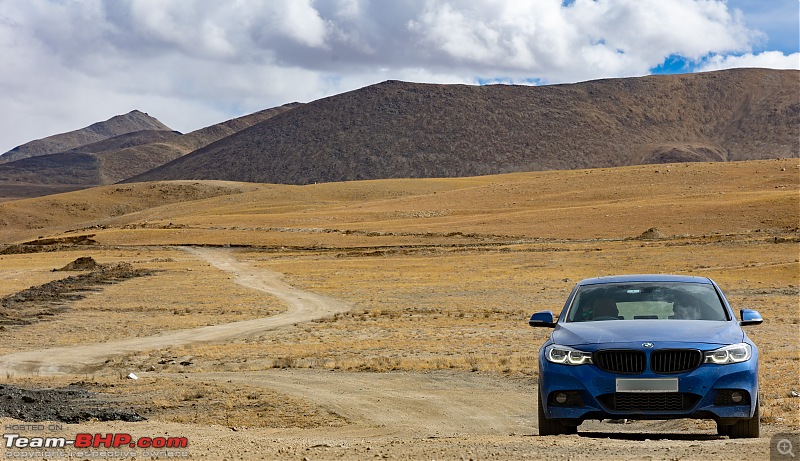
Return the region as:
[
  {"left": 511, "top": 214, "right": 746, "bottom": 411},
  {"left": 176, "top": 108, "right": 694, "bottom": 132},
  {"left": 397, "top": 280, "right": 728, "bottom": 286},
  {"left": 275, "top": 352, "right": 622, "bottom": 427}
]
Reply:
[{"left": 0, "top": 249, "right": 788, "bottom": 460}]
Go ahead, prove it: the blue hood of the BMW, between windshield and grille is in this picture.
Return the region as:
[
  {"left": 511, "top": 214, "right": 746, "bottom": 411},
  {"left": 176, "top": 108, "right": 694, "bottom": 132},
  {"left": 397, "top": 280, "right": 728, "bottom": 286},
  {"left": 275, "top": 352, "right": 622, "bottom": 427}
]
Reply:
[{"left": 551, "top": 320, "right": 744, "bottom": 346}]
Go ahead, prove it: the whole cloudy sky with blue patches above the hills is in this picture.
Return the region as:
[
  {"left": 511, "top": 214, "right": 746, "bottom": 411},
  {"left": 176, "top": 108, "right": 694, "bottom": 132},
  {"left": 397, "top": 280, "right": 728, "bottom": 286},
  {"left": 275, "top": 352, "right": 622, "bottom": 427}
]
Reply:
[{"left": 0, "top": 0, "right": 800, "bottom": 153}]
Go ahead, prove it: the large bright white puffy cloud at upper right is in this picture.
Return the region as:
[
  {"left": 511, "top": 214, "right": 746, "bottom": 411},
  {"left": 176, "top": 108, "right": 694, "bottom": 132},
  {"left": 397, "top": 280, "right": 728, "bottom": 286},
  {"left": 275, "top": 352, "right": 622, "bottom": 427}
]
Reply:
[{"left": 409, "top": 0, "right": 759, "bottom": 82}]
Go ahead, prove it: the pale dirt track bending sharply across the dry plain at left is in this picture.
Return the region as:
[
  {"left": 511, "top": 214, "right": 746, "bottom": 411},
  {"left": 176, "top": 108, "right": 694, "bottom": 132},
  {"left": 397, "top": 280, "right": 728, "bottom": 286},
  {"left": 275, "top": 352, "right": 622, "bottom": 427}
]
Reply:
[{"left": 0, "top": 248, "right": 349, "bottom": 375}]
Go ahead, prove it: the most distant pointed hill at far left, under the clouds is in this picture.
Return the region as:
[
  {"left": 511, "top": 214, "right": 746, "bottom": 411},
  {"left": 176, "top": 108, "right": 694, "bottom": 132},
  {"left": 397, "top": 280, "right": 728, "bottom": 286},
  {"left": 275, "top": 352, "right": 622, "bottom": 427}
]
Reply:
[{"left": 0, "top": 110, "right": 172, "bottom": 163}]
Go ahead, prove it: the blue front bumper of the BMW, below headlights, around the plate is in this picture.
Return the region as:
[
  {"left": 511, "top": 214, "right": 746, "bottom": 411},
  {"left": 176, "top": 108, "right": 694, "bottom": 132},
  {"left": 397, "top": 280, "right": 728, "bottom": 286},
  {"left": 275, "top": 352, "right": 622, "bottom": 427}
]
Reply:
[{"left": 539, "top": 354, "right": 758, "bottom": 424}]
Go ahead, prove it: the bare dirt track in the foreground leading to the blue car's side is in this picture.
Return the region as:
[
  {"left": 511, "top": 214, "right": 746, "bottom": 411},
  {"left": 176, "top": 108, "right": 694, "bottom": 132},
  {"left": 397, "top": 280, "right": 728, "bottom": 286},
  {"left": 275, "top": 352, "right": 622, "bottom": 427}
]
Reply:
[{"left": 191, "top": 370, "right": 535, "bottom": 437}]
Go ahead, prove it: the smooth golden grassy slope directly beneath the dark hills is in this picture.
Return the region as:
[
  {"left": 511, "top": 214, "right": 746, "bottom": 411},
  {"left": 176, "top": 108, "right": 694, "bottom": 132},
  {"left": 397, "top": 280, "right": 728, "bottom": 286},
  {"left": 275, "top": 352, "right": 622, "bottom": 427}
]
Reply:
[{"left": 0, "top": 159, "right": 800, "bottom": 248}]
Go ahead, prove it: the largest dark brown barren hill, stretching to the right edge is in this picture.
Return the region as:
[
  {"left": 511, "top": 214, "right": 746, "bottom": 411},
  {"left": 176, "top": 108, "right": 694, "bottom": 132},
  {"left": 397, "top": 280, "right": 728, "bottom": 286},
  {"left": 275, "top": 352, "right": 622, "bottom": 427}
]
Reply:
[{"left": 129, "top": 69, "right": 800, "bottom": 184}]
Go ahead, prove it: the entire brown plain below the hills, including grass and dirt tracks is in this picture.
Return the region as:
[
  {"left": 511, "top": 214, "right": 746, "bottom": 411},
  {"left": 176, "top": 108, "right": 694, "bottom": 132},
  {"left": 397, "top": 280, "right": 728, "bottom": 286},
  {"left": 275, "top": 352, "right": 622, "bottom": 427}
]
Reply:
[{"left": 0, "top": 159, "right": 800, "bottom": 460}]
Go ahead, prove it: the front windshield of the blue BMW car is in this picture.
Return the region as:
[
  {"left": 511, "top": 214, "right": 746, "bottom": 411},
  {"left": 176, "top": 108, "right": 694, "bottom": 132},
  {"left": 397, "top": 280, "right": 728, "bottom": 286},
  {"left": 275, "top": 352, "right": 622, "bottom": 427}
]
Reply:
[{"left": 567, "top": 282, "right": 729, "bottom": 322}]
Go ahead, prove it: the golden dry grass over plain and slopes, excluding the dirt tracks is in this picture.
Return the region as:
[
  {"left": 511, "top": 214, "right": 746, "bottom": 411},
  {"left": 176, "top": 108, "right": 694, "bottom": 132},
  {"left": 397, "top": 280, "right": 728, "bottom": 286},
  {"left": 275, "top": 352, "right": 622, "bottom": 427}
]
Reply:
[{"left": 0, "top": 160, "right": 800, "bottom": 429}]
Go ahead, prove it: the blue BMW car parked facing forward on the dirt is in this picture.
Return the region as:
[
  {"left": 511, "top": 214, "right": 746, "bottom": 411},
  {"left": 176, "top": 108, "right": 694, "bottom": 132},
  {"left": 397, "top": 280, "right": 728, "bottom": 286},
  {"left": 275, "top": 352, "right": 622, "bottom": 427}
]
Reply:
[{"left": 529, "top": 275, "right": 762, "bottom": 438}]
